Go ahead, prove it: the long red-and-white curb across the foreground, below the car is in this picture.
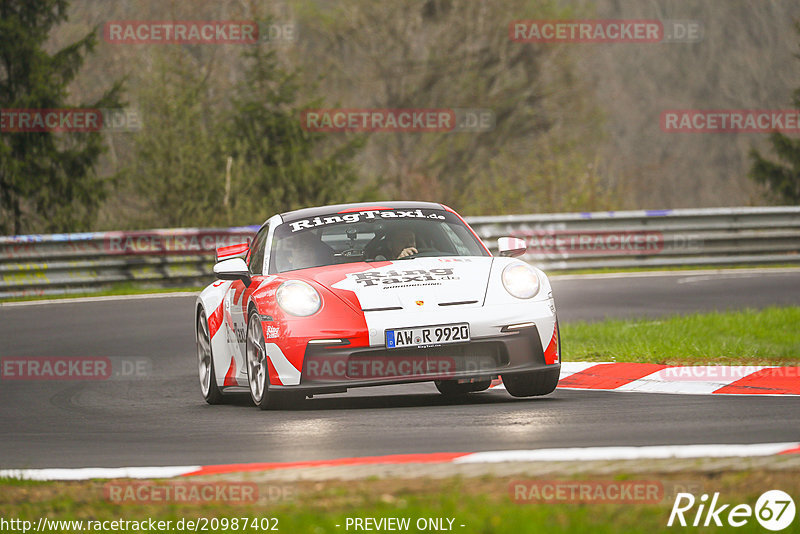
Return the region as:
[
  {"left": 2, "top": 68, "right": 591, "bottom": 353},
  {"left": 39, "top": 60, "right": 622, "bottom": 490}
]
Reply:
[{"left": 0, "top": 442, "right": 800, "bottom": 480}]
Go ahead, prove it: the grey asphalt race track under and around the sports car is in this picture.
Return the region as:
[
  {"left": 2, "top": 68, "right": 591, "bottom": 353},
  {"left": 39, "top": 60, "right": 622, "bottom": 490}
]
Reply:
[{"left": 0, "top": 270, "right": 800, "bottom": 468}]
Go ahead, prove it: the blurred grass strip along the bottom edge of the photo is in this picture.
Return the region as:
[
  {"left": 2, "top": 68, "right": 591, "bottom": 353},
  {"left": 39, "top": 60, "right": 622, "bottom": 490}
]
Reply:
[{"left": 0, "top": 469, "right": 800, "bottom": 534}]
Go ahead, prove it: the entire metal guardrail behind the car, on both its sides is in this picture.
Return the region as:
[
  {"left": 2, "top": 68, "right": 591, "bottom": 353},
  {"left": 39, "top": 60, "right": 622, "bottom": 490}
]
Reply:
[{"left": 0, "top": 207, "right": 800, "bottom": 299}]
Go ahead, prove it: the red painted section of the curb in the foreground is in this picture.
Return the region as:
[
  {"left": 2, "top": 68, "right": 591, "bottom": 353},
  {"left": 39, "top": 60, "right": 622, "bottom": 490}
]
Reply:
[{"left": 182, "top": 452, "right": 471, "bottom": 476}]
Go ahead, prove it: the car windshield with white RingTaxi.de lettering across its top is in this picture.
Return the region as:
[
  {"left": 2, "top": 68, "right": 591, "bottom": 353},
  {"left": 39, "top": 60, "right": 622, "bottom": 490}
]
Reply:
[{"left": 269, "top": 209, "right": 489, "bottom": 273}]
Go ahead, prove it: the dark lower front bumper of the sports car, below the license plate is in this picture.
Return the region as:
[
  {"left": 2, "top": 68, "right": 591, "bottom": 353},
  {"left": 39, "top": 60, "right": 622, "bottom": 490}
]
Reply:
[{"left": 270, "top": 326, "right": 561, "bottom": 394}]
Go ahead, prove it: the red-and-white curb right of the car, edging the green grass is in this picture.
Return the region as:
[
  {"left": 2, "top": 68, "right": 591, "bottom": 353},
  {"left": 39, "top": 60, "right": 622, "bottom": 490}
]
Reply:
[{"left": 495, "top": 362, "right": 800, "bottom": 395}]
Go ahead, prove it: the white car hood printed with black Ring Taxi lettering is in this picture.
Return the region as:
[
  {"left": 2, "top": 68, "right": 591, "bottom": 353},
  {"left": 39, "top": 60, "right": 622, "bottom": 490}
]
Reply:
[{"left": 322, "top": 256, "right": 493, "bottom": 310}]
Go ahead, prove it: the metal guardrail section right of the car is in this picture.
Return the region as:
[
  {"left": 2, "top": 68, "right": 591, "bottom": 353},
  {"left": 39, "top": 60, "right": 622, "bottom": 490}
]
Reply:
[{"left": 467, "top": 207, "right": 800, "bottom": 271}]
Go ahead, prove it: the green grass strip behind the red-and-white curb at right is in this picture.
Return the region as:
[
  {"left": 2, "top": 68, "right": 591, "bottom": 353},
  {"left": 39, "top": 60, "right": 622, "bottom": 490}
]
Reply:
[{"left": 561, "top": 307, "right": 800, "bottom": 365}]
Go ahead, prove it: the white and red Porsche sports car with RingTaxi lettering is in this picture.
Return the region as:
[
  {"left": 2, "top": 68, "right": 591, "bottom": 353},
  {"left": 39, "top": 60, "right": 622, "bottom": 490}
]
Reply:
[{"left": 195, "top": 202, "right": 561, "bottom": 409}]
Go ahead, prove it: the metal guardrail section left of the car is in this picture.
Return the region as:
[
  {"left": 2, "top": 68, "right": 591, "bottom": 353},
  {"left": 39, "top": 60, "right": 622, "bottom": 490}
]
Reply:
[{"left": 0, "top": 226, "right": 258, "bottom": 299}]
